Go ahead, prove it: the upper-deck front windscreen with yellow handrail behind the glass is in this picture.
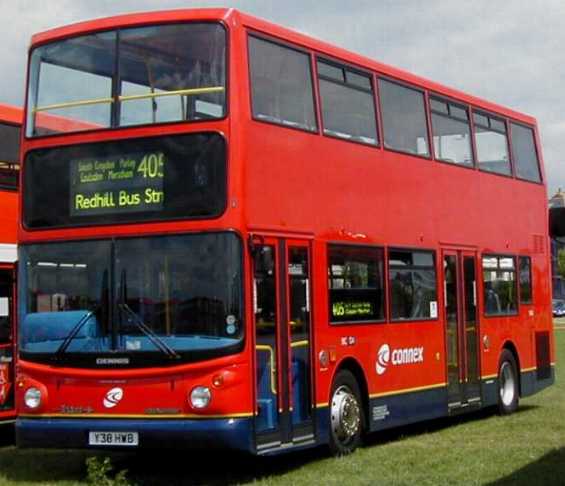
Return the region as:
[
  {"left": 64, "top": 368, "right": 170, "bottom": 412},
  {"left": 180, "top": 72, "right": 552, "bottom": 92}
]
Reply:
[{"left": 26, "top": 22, "right": 226, "bottom": 137}]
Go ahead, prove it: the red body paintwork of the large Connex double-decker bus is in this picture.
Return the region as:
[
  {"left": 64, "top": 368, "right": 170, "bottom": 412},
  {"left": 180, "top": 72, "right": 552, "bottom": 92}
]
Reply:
[{"left": 19, "top": 9, "right": 554, "bottom": 430}]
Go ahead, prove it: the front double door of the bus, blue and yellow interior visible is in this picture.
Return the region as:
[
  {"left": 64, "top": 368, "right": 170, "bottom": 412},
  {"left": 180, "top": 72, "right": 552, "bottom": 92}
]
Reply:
[{"left": 251, "top": 237, "right": 314, "bottom": 453}]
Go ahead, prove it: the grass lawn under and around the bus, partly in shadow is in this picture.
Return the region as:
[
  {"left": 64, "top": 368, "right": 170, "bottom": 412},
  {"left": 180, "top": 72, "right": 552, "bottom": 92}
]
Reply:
[{"left": 0, "top": 323, "right": 565, "bottom": 486}]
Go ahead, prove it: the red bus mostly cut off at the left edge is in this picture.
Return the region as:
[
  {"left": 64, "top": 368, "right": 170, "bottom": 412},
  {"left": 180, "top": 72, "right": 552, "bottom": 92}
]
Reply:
[{"left": 0, "top": 104, "right": 23, "bottom": 424}]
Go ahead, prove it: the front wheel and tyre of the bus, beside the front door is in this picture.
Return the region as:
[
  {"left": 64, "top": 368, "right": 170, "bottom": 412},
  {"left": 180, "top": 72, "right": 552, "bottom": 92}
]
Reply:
[{"left": 329, "top": 370, "right": 365, "bottom": 456}]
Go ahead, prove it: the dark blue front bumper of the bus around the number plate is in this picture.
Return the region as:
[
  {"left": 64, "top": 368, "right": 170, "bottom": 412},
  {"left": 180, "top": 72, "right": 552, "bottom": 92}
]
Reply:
[{"left": 16, "top": 418, "right": 254, "bottom": 452}]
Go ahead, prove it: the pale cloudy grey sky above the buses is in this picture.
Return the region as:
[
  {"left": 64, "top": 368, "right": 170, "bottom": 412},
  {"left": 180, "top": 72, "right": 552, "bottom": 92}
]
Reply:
[{"left": 0, "top": 0, "right": 565, "bottom": 195}]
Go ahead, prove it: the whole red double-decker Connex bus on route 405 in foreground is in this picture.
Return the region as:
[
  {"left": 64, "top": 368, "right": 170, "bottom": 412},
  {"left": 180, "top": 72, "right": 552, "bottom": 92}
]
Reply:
[{"left": 17, "top": 10, "right": 554, "bottom": 454}]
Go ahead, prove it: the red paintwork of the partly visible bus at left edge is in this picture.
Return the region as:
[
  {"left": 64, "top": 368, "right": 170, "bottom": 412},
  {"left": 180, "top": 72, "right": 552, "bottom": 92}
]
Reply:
[{"left": 0, "top": 104, "right": 23, "bottom": 423}]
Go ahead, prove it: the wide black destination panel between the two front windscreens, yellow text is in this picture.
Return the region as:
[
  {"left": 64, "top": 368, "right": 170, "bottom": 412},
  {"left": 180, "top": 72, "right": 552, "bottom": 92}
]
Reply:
[{"left": 22, "top": 132, "right": 227, "bottom": 229}]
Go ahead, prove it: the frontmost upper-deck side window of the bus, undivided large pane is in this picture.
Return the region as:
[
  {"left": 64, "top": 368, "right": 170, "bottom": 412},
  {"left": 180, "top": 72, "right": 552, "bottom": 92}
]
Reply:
[{"left": 248, "top": 35, "right": 318, "bottom": 132}]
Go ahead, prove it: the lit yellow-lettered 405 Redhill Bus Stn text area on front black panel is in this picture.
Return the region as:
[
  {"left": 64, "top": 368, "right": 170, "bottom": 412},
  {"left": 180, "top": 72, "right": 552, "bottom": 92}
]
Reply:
[{"left": 69, "top": 152, "right": 167, "bottom": 217}]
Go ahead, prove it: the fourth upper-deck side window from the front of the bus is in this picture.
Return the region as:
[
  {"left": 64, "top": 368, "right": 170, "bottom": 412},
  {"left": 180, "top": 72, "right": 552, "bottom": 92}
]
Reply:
[{"left": 430, "top": 96, "right": 473, "bottom": 167}]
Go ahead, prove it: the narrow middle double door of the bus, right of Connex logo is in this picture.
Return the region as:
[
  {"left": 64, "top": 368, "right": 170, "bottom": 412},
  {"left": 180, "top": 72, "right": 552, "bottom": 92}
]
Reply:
[{"left": 443, "top": 250, "right": 481, "bottom": 413}]
